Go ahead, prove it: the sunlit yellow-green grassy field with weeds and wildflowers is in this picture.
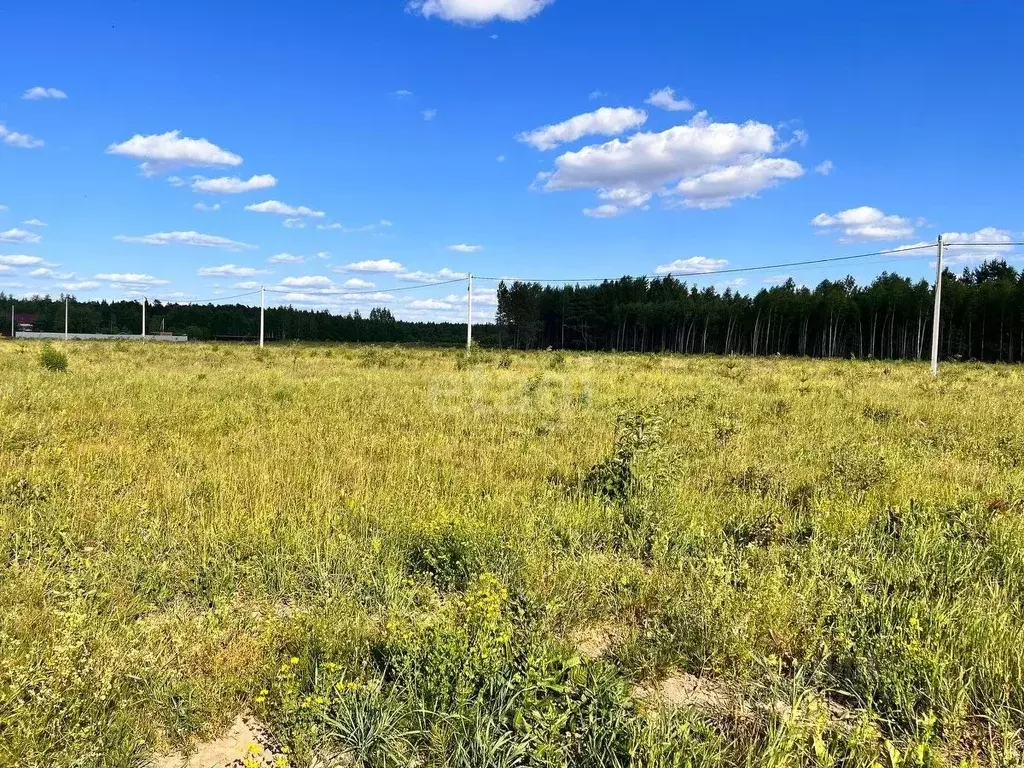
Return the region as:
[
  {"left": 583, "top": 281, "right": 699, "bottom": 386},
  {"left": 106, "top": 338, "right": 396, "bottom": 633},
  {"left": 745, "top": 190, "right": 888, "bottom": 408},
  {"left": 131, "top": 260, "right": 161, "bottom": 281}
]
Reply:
[{"left": 0, "top": 342, "right": 1024, "bottom": 768}]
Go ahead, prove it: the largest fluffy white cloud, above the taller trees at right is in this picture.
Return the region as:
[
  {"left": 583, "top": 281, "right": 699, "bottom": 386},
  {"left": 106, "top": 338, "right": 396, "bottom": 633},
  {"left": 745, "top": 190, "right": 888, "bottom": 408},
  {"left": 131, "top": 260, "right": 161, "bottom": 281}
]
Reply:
[{"left": 536, "top": 113, "right": 804, "bottom": 218}]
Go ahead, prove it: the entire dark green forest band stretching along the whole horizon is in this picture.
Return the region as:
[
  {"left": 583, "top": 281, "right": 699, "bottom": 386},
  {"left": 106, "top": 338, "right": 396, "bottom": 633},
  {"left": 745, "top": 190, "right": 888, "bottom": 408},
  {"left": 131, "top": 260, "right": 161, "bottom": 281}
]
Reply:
[{"left": 6, "top": 260, "right": 1024, "bottom": 362}]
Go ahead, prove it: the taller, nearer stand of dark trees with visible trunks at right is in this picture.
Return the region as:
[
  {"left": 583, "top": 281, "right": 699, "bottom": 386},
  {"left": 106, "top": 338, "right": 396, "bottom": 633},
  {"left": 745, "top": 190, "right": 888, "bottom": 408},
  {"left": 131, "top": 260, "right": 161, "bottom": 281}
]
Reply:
[{"left": 497, "top": 260, "right": 1024, "bottom": 362}]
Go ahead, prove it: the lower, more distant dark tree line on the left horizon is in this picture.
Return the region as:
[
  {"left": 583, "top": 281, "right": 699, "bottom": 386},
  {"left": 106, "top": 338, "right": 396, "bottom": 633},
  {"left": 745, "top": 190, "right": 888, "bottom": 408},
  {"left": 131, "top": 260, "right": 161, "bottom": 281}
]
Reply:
[{"left": 0, "top": 292, "right": 498, "bottom": 346}]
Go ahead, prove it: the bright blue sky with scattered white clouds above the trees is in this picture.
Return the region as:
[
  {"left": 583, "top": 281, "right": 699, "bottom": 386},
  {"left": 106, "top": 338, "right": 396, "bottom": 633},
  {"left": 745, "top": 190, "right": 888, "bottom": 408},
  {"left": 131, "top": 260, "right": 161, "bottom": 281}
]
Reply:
[{"left": 0, "top": 0, "right": 1024, "bottom": 318}]
